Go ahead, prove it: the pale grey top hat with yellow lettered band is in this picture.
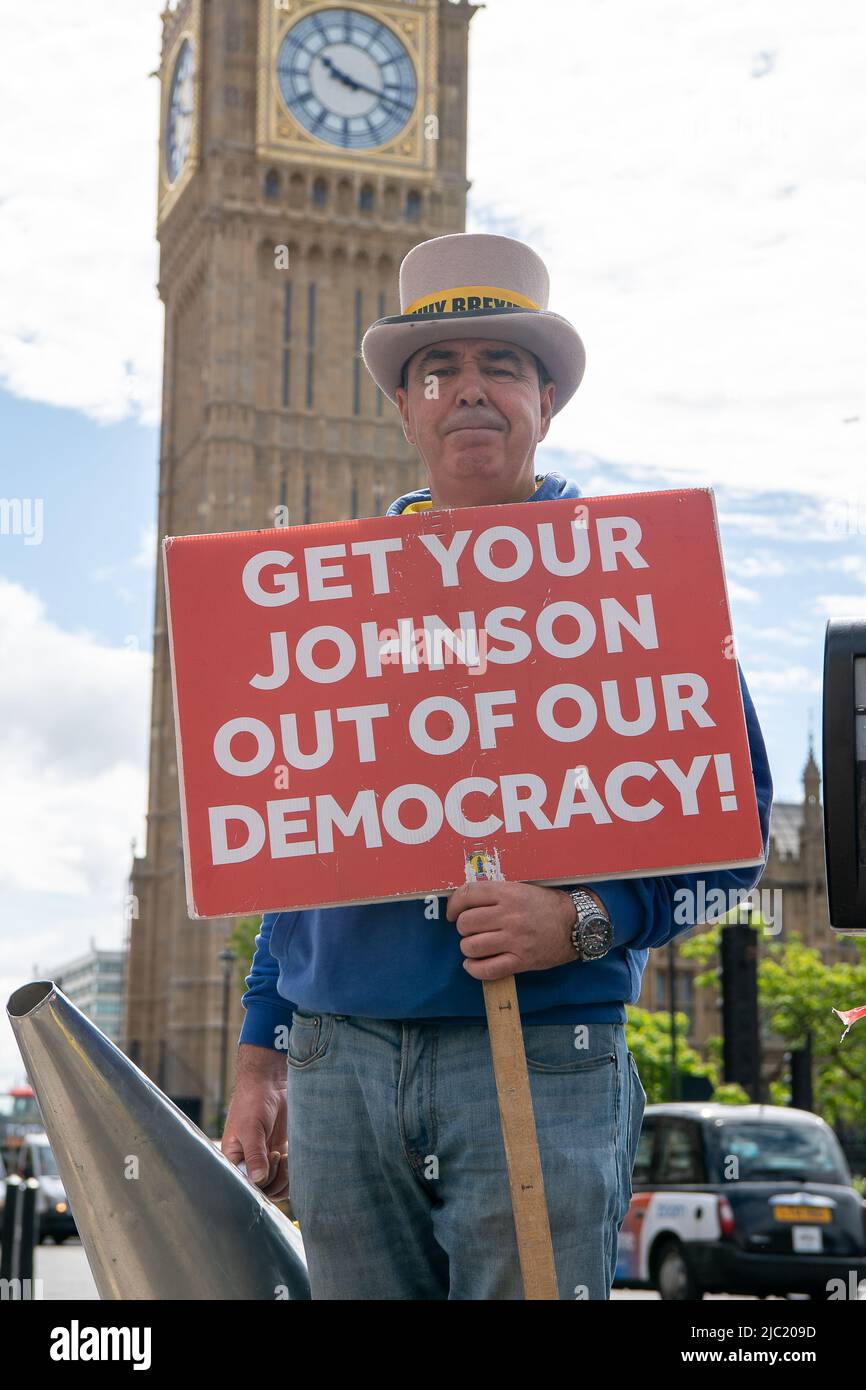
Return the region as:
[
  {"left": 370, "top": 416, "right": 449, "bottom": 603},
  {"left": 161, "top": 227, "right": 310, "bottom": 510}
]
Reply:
[{"left": 361, "top": 232, "right": 587, "bottom": 414}]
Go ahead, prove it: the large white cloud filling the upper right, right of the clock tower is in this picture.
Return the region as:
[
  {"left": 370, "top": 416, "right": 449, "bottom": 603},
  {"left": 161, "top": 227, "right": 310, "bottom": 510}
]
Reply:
[{"left": 470, "top": 0, "right": 866, "bottom": 495}]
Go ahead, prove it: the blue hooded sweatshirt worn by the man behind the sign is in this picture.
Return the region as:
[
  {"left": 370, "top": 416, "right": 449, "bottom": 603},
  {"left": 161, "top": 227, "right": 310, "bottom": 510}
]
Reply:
[{"left": 239, "top": 473, "right": 773, "bottom": 1048}]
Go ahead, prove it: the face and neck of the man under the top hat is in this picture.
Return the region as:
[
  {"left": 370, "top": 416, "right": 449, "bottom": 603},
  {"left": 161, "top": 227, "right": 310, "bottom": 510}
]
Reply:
[{"left": 396, "top": 338, "right": 555, "bottom": 506}]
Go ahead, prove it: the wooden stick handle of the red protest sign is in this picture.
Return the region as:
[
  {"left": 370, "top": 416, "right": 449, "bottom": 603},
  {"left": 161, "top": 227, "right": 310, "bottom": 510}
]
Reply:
[{"left": 466, "top": 851, "right": 559, "bottom": 1300}]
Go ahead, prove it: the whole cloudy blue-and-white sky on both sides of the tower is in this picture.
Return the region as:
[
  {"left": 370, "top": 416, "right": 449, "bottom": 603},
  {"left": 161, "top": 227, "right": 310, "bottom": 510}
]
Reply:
[{"left": 0, "top": 0, "right": 866, "bottom": 1083}]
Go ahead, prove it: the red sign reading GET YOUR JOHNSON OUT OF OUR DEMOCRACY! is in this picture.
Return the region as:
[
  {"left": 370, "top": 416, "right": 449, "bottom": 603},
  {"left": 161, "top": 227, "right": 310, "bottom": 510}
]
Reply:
[{"left": 163, "top": 489, "right": 763, "bottom": 917}]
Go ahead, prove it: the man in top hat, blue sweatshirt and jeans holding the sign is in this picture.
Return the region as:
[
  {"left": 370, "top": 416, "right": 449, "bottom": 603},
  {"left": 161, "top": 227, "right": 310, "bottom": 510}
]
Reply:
[{"left": 222, "top": 234, "right": 773, "bottom": 1300}]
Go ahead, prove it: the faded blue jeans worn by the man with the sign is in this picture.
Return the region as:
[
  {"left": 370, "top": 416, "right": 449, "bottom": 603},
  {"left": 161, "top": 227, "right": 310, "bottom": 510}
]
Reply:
[{"left": 288, "top": 1009, "right": 646, "bottom": 1300}]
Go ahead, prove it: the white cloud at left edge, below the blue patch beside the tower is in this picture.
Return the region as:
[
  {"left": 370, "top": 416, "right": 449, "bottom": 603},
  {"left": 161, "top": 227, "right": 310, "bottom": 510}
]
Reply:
[{"left": 0, "top": 580, "right": 152, "bottom": 898}]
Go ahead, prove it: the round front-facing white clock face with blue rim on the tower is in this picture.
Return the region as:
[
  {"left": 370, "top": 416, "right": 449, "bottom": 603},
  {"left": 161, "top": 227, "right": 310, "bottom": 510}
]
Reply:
[{"left": 277, "top": 10, "right": 418, "bottom": 150}]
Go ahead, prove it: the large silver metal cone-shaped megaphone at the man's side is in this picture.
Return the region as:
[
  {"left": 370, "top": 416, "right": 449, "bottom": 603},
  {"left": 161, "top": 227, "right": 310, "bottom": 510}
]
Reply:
[{"left": 7, "top": 980, "right": 310, "bottom": 1302}]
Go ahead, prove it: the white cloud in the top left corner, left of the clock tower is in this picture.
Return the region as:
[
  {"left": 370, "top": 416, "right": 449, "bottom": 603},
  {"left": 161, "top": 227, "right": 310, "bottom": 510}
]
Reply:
[{"left": 0, "top": 0, "right": 163, "bottom": 423}]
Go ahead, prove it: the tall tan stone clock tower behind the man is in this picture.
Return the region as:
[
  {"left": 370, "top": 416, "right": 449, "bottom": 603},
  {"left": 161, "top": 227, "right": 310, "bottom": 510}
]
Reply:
[{"left": 125, "top": 0, "right": 477, "bottom": 1127}]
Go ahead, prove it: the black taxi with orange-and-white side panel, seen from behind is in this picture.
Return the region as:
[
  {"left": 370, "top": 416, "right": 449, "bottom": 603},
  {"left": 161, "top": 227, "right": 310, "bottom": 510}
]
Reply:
[{"left": 614, "top": 1102, "right": 866, "bottom": 1300}]
